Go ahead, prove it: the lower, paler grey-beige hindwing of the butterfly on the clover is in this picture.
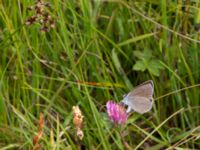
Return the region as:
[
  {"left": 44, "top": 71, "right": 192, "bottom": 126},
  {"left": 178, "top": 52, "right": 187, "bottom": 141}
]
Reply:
[{"left": 129, "top": 96, "right": 153, "bottom": 114}]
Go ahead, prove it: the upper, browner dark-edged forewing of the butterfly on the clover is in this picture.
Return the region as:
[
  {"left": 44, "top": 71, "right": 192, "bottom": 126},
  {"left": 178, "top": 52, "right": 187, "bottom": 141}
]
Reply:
[{"left": 128, "top": 80, "right": 154, "bottom": 99}]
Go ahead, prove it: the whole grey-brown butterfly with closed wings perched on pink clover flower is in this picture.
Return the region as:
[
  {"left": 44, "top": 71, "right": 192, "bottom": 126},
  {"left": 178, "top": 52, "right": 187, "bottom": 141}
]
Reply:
[{"left": 122, "top": 80, "right": 154, "bottom": 114}]
